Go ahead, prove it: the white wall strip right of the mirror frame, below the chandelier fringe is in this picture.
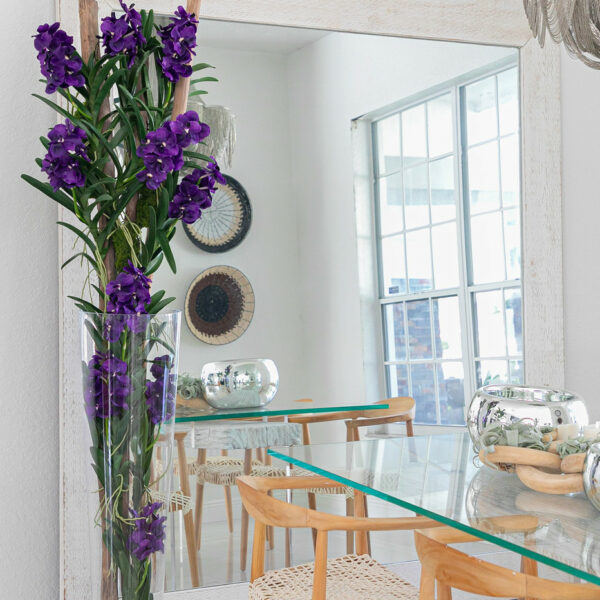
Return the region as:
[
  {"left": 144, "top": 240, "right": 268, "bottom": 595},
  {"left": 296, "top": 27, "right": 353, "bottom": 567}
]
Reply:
[{"left": 553, "top": 50, "right": 600, "bottom": 420}]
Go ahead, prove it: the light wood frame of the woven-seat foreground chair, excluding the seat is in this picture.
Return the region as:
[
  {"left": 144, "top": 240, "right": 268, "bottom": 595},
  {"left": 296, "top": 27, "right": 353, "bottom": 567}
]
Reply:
[{"left": 238, "top": 476, "right": 440, "bottom": 600}]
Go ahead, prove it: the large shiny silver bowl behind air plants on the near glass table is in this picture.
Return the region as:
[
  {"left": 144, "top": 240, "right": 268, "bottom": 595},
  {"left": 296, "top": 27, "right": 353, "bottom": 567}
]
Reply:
[{"left": 466, "top": 385, "right": 588, "bottom": 449}]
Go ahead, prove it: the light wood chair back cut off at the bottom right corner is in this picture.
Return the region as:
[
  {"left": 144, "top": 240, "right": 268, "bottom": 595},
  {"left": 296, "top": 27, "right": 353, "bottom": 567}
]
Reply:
[{"left": 415, "top": 527, "right": 600, "bottom": 600}]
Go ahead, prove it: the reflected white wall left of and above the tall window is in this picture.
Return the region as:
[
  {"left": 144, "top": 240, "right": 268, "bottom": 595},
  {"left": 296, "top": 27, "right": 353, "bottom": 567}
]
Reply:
[{"left": 289, "top": 33, "right": 512, "bottom": 412}]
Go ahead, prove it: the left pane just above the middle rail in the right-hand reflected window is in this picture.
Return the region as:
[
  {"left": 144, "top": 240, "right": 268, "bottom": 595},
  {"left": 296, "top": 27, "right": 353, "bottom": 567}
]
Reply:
[{"left": 471, "top": 212, "right": 504, "bottom": 284}]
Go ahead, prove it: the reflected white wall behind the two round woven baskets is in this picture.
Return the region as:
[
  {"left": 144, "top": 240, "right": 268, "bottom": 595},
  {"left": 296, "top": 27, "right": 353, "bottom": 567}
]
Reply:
[{"left": 153, "top": 47, "right": 304, "bottom": 398}]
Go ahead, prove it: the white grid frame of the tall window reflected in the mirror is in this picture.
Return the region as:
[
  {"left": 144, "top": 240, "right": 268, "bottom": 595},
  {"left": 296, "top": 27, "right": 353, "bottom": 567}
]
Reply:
[{"left": 370, "top": 56, "right": 525, "bottom": 427}]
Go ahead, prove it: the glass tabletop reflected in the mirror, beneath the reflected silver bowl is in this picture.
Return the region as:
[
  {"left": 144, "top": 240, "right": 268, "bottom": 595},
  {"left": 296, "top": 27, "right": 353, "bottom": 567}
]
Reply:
[{"left": 175, "top": 398, "right": 388, "bottom": 423}]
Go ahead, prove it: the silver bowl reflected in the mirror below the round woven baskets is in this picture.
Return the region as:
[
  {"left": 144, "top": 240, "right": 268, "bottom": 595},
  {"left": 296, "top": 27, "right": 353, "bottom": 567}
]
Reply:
[{"left": 200, "top": 358, "right": 279, "bottom": 408}]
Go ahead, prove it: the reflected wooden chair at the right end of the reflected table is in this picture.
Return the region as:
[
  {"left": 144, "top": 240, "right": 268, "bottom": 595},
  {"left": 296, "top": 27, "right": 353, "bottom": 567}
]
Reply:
[{"left": 289, "top": 396, "right": 415, "bottom": 553}]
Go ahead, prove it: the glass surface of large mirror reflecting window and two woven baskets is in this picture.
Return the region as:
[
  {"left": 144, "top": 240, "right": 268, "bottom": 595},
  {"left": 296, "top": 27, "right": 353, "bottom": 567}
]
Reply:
[{"left": 150, "top": 21, "right": 524, "bottom": 590}]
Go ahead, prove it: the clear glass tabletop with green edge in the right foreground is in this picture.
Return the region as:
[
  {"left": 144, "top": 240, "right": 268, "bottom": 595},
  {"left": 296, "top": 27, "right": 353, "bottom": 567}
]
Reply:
[{"left": 269, "top": 433, "right": 600, "bottom": 584}]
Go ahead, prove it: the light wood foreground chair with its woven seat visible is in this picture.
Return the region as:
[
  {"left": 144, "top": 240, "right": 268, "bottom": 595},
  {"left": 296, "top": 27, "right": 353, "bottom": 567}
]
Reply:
[{"left": 238, "top": 477, "right": 438, "bottom": 600}]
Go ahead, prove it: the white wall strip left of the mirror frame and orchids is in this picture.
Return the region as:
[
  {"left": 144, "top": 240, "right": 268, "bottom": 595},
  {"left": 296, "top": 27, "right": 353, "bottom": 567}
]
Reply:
[{"left": 0, "top": 0, "right": 59, "bottom": 600}]
